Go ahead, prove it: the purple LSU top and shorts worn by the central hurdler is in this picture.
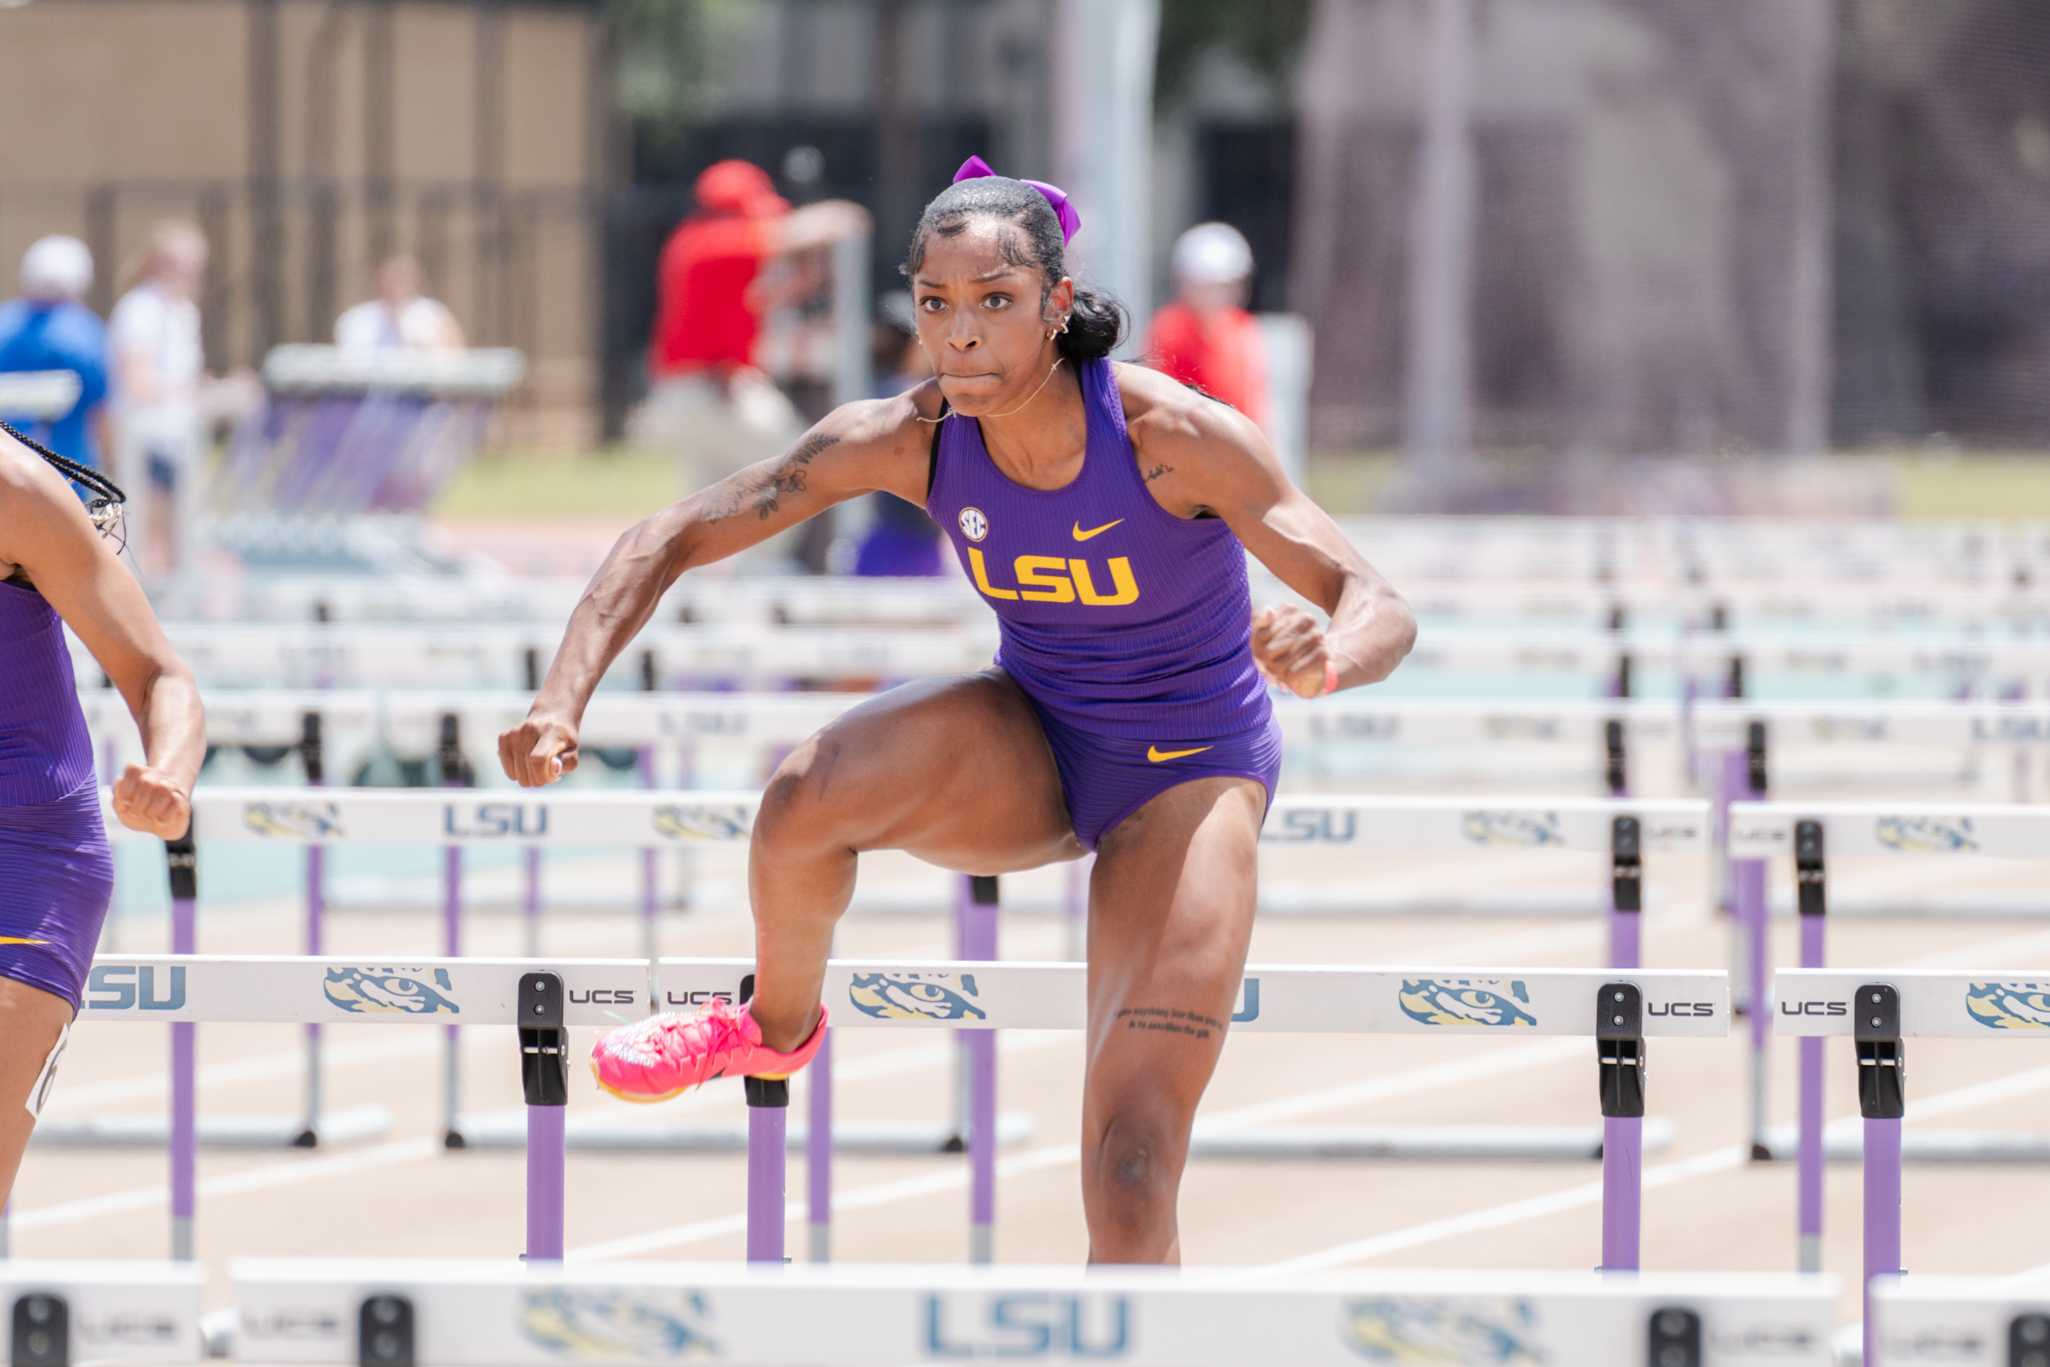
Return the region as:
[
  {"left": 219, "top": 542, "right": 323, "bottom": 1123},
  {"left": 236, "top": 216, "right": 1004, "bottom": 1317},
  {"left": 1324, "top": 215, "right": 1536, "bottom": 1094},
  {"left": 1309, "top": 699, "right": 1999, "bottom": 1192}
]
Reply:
[{"left": 927, "top": 361, "right": 1281, "bottom": 848}]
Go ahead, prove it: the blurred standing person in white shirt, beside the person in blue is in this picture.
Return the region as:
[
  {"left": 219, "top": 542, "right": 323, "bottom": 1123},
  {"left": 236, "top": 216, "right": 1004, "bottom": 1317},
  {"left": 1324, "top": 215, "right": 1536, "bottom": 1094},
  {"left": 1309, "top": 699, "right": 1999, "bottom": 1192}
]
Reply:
[{"left": 107, "top": 221, "right": 207, "bottom": 574}]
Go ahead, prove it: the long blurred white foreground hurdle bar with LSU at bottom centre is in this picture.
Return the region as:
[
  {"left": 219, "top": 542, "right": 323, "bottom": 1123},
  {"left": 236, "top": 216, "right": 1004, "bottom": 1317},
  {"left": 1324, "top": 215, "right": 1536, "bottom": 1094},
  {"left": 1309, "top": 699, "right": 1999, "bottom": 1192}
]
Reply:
[{"left": 230, "top": 1260, "right": 1837, "bottom": 1367}]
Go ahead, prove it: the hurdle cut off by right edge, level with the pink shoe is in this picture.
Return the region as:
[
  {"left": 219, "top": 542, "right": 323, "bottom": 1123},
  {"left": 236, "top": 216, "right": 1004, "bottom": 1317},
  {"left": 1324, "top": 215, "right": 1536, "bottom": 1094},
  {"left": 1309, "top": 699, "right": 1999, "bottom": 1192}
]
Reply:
[{"left": 1775, "top": 969, "right": 2050, "bottom": 1367}]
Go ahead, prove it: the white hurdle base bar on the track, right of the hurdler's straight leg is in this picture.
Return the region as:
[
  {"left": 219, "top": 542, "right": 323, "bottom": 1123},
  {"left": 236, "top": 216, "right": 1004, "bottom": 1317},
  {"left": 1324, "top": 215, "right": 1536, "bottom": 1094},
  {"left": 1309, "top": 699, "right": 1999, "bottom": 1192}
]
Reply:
[{"left": 1189, "top": 1119, "right": 1673, "bottom": 1162}]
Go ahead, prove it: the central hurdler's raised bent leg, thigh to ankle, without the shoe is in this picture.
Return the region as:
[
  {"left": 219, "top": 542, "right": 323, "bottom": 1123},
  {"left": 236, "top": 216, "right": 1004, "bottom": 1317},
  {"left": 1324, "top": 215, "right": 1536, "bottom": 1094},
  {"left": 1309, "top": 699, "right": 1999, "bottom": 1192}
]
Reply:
[{"left": 748, "top": 670, "right": 1082, "bottom": 1049}]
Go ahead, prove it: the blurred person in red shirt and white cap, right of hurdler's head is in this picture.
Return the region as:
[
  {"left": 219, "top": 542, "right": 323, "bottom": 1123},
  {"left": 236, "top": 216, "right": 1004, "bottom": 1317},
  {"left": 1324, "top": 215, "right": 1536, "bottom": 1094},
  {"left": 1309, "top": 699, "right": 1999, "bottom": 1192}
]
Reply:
[{"left": 1146, "top": 223, "right": 1267, "bottom": 428}]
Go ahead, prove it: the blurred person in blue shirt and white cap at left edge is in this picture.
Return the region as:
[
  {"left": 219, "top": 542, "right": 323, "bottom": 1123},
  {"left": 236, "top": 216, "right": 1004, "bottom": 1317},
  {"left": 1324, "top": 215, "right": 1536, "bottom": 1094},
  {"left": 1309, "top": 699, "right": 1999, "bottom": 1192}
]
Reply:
[{"left": 0, "top": 238, "right": 107, "bottom": 479}]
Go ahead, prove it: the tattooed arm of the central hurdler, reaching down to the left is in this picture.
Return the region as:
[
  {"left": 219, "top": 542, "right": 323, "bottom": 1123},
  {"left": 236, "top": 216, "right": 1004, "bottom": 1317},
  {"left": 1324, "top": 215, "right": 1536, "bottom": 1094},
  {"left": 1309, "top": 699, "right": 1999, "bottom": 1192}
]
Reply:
[{"left": 498, "top": 385, "right": 939, "bottom": 787}]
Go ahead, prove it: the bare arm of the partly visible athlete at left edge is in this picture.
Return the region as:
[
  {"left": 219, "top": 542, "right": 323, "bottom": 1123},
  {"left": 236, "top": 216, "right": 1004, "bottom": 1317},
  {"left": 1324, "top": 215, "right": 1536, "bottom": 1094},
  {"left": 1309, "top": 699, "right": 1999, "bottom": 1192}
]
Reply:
[{"left": 0, "top": 437, "right": 207, "bottom": 840}]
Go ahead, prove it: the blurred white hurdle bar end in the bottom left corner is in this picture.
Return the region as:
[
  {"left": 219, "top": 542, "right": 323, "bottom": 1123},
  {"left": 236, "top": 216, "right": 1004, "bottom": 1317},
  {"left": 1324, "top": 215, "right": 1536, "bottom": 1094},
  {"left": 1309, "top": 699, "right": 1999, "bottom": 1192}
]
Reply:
[{"left": 0, "top": 1258, "right": 203, "bottom": 1367}]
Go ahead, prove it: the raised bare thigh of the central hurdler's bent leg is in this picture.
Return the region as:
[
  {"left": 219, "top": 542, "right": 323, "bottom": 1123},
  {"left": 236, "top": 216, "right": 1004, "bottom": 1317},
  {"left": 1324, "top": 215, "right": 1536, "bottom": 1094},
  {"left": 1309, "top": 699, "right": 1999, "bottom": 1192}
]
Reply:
[{"left": 765, "top": 670, "right": 1082, "bottom": 873}]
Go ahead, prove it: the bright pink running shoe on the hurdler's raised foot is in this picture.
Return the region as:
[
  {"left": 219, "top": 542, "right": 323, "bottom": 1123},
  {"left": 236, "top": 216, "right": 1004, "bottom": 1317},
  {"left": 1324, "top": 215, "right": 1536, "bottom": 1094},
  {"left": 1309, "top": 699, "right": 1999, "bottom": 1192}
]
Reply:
[{"left": 590, "top": 1000, "right": 826, "bottom": 1103}]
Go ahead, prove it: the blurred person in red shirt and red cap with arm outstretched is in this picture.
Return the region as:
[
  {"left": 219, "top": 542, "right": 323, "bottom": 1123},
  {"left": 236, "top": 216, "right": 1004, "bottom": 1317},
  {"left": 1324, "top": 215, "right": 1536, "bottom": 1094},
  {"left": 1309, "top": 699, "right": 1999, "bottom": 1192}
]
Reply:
[{"left": 631, "top": 162, "right": 869, "bottom": 492}]
